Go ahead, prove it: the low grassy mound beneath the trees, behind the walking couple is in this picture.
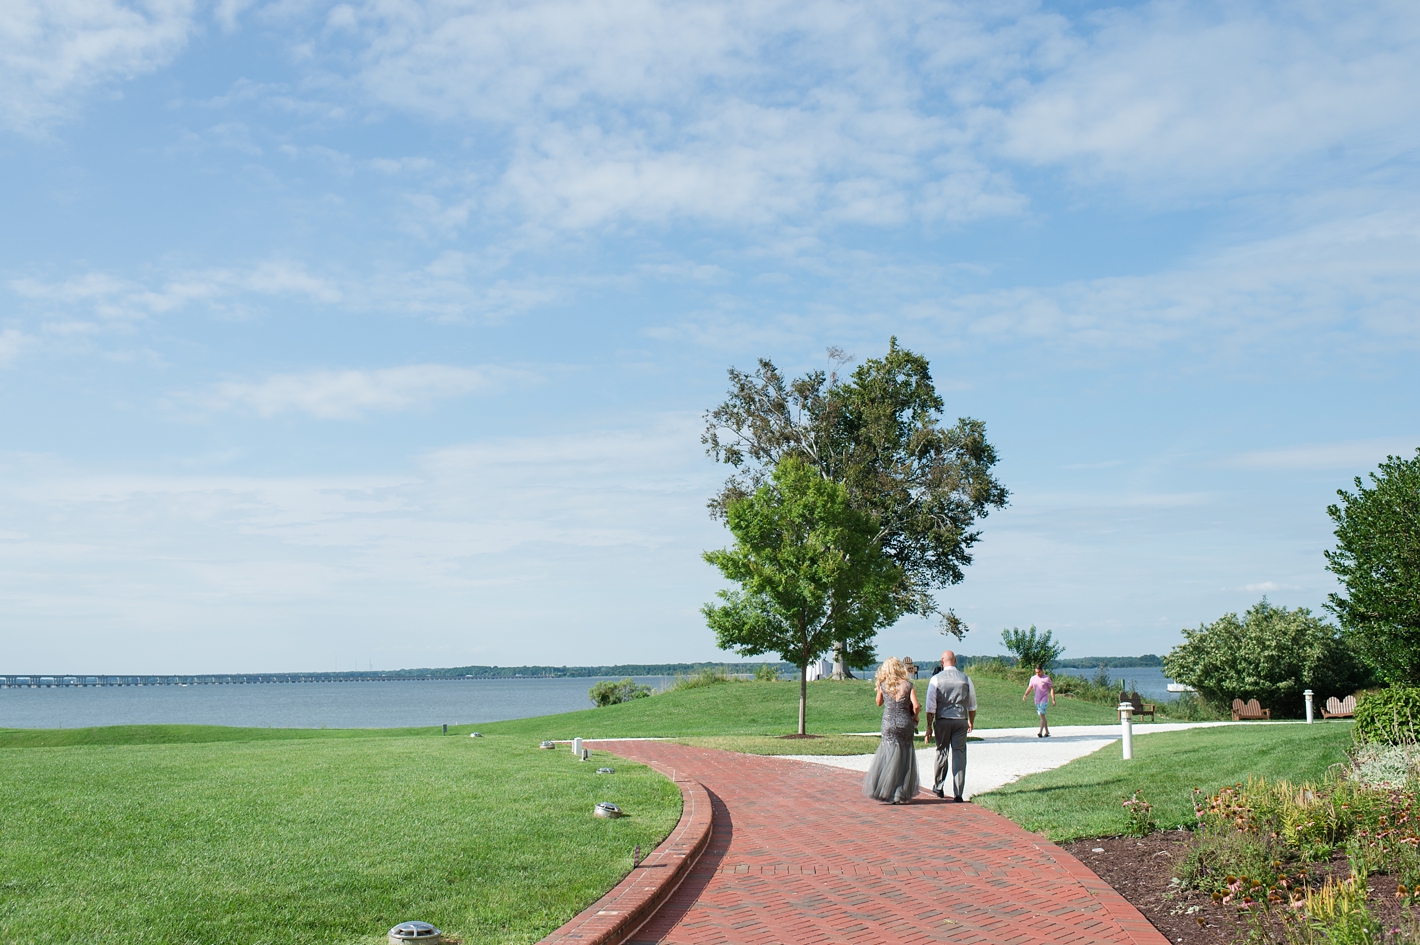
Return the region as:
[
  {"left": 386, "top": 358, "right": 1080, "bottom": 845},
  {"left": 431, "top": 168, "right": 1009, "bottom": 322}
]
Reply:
[{"left": 477, "top": 678, "right": 1118, "bottom": 738}]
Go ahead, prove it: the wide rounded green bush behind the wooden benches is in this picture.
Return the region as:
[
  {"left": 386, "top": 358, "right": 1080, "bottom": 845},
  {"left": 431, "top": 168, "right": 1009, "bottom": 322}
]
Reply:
[{"left": 1163, "top": 597, "right": 1370, "bottom": 718}]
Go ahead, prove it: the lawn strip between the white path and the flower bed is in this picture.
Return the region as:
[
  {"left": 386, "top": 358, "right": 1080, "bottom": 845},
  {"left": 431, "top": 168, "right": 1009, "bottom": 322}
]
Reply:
[{"left": 968, "top": 722, "right": 1350, "bottom": 841}]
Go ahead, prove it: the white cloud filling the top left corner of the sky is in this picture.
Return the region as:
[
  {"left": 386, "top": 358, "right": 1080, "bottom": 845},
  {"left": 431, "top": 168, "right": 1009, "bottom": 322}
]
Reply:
[{"left": 0, "top": 0, "right": 193, "bottom": 134}]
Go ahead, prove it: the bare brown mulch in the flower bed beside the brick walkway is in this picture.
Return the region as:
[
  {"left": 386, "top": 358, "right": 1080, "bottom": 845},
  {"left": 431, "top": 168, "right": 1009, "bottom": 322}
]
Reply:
[{"left": 1061, "top": 830, "right": 1400, "bottom": 945}]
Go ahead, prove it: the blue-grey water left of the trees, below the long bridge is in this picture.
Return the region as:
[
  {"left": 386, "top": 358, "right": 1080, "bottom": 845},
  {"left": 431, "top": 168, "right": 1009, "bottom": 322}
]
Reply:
[{"left": 0, "top": 676, "right": 675, "bottom": 729}]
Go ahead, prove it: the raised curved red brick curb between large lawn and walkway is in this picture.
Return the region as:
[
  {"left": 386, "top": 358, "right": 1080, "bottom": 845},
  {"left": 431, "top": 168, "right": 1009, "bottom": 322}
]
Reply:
[{"left": 538, "top": 762, "right": 711, "bottom": 945}]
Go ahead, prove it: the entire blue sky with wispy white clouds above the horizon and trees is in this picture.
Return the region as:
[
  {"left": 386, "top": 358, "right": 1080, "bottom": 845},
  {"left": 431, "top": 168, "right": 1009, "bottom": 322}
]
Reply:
[{"left": 0, "top": 0, "right": 1420, "bottom": 672}]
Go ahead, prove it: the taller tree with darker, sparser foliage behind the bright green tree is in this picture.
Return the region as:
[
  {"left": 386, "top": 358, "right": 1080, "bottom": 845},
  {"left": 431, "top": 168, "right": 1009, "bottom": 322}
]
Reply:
[{"left": 701, "top": 338, "right": 1008, "bottom": 665}]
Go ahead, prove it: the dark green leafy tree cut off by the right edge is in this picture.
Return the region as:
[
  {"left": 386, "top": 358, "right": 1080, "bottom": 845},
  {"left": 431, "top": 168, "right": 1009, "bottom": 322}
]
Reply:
[{"left": 1326, "top": 449, "right": 1420, "bottom": 685}]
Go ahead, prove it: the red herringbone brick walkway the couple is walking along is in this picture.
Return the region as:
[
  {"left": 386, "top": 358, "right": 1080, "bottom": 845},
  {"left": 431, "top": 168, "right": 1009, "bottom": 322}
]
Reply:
[{"left": 596, "top": 742, "right": 1169, "bottom": 945}]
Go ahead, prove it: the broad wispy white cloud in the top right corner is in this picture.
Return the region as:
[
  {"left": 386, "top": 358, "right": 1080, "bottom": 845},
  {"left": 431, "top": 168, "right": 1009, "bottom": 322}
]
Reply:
[{"left": 1004, "top": 0, "right": 1420, "bottom": 193}]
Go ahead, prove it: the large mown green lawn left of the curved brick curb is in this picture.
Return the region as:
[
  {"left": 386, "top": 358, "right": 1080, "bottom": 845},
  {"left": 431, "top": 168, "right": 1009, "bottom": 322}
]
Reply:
[{"left": 0, "top": 726, "right": 680, "bottom": 945}]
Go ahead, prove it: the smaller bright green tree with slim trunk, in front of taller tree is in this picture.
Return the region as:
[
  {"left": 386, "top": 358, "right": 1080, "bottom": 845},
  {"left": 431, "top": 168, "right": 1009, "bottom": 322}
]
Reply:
[{"left": 703, "top": 456, "right": 902, "bottom": 735}]
